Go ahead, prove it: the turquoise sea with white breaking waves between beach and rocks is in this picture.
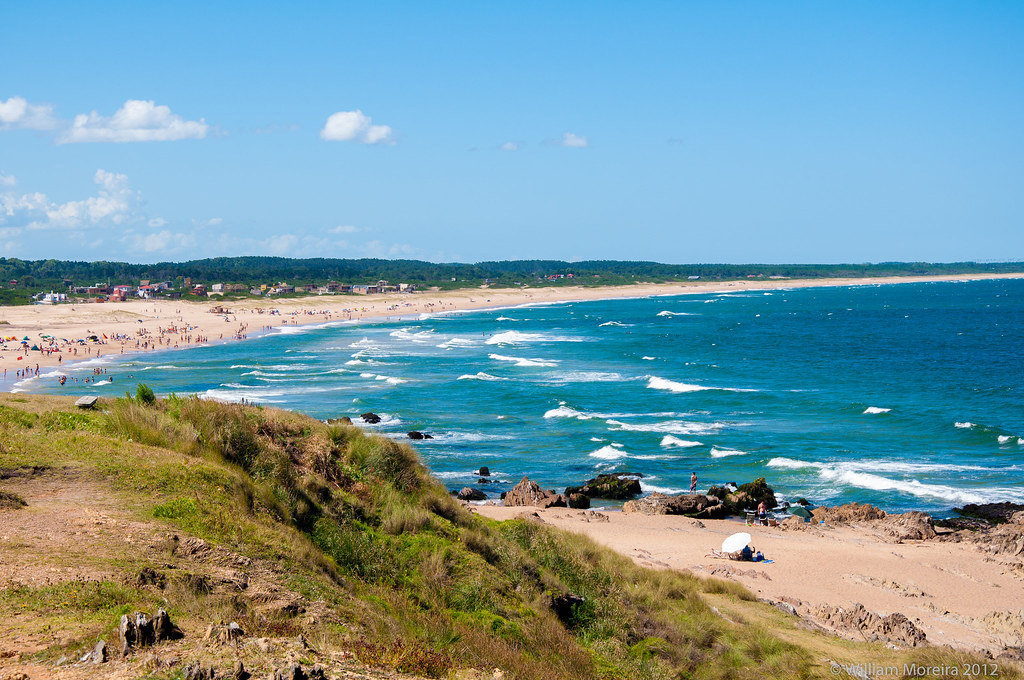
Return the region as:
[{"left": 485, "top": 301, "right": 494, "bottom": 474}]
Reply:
[{"left": 17, "top": 280, "right": 1024, "bottom": 514}]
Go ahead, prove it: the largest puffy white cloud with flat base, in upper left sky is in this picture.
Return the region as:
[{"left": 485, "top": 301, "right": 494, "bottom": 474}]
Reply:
[{"left": 57, "top": 99, "right": 210, "bottom": 144}]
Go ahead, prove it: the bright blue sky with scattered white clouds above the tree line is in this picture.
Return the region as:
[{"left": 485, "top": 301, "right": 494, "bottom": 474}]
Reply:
[{"left": 0, "top": 1, "right": 1024, "bottom": 262}]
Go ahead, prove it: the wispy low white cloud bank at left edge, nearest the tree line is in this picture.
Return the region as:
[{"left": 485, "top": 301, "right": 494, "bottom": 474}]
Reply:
[{"left": 0, "top": 169, "right": 139, "bottom": 230}]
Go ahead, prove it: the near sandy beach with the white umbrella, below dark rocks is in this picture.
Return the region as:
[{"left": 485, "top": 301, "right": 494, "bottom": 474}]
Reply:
[{"left": 474, "top": 505, "right": 1024, "bottom": 654}]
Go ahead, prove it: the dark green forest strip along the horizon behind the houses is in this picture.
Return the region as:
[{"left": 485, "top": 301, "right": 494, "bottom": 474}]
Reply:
[{"left": 0, "top": 257, "right": 1024, "bottom": 304}]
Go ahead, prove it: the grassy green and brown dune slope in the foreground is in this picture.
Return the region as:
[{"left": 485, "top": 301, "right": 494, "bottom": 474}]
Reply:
[{"left": 0, "top": 390, "right": 1020, "bottom": 679}]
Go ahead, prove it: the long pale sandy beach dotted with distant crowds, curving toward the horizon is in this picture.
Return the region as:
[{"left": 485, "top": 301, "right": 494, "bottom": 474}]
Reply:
[{"left": 0, "top": 272, "right": 1024, "bottom": 391}]
